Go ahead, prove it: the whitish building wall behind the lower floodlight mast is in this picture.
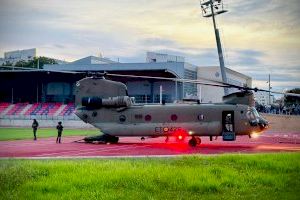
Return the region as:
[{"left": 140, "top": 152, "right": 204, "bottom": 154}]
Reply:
[{"left": 197, "top": 66, "right": 252, "bottom": 103}]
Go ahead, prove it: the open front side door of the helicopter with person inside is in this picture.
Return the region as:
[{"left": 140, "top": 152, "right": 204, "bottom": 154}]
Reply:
[{"left": 222, "top": 111, "right": 235, "bottom": 141}]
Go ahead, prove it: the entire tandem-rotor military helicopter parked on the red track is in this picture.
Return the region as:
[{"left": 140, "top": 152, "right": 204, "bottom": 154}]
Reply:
[{"left": 75, "top": 73, "right": 274, "bottom": 146}]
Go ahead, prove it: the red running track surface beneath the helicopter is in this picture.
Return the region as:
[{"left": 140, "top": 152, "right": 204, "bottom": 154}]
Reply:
[{"left": 0, "top": 132, "right": 300, "bottom": 158}]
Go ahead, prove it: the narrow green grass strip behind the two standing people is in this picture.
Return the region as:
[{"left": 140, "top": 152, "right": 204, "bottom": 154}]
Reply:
[{"left": 0, "top": 128, "right": 99, "bottom": 141}]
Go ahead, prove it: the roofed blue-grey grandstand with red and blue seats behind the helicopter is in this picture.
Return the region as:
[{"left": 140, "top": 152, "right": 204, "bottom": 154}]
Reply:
[{"left": 0, "top": 52, "right": 251, "bottom": 119}]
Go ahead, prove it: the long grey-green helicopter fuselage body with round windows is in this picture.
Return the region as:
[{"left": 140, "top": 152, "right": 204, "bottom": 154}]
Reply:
[{"left": 76, "top": 104, "right": 263, "bottom": 137}]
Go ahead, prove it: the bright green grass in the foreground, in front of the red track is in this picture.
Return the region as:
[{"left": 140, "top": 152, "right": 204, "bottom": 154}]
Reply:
[{"left": 0, "top": 153, "right": 300, "bottom": 200}]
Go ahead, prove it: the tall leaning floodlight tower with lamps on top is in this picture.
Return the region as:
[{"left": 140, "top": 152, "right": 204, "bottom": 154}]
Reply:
[{"left": 200, "top": 0, "right": 228, "bottom": 95}]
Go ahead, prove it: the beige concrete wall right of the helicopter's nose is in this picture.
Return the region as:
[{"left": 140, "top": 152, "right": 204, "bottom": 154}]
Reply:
[{"left": 262, "top": 114, "right": 300, "bottom": 133}]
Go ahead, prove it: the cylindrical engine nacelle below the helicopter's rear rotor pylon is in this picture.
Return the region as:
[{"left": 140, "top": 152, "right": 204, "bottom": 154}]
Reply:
[{"left": 81, "top": 96, "right": 133, "bottom": 108}]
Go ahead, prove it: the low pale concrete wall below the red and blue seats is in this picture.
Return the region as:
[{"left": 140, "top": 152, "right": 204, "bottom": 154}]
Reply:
[{"left": 0, "top": 119, "right": 94, "bottom": 129}]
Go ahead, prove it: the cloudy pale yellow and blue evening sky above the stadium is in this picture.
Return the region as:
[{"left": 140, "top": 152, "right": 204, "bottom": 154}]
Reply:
[{"left": 0, "top": 0, "right": 300, "bottom": 94}]
